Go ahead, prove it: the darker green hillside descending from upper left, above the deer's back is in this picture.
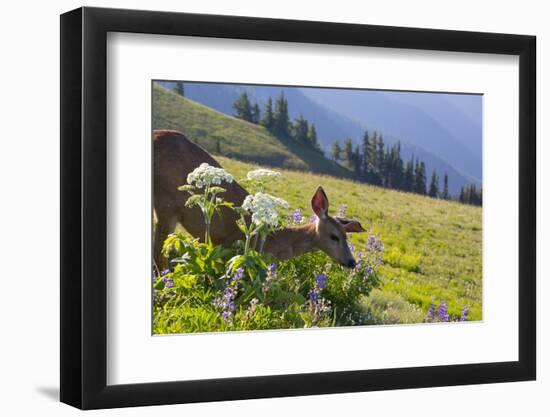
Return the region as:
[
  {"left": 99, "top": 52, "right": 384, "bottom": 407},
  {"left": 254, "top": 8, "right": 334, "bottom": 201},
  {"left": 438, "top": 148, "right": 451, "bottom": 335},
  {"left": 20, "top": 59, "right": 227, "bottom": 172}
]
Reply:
[{"left": 153, "top": 84, "right": 353, "bottom": 178}]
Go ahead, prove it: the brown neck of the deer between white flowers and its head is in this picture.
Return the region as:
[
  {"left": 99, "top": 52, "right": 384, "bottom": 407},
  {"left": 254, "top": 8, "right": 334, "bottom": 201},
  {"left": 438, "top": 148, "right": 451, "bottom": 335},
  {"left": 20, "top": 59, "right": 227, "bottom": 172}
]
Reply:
[{"left": 264, "top": 223, "right": 318, "bottom": 260}]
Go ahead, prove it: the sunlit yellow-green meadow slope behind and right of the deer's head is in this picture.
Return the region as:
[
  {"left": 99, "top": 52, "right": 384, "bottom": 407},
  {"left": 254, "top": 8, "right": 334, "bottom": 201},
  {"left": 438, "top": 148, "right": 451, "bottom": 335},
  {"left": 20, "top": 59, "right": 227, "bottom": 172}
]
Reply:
[{"left": 217, "top": 157, "right": 482, "bottom": 323}]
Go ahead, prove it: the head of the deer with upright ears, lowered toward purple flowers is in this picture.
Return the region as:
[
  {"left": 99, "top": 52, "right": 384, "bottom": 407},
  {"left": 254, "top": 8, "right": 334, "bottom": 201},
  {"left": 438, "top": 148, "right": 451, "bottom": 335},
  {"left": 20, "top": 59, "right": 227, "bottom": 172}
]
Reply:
[{"left": 311, "top": 187, "right": 365, "bottom": 268}]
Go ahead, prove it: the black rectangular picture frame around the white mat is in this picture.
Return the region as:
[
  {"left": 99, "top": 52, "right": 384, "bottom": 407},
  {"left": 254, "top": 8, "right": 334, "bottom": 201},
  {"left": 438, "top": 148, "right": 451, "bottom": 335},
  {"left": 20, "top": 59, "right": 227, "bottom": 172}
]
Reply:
[{"left": 60, "top": 7, "right": 536, "bottom": 409}]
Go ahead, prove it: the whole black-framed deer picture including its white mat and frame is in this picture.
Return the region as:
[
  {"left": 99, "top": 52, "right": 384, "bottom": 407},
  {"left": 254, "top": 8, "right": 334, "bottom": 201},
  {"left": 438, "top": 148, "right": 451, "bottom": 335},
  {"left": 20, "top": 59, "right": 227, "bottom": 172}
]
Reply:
[{"left": 61, "top": 7, "right": 536, "bottom": 409}]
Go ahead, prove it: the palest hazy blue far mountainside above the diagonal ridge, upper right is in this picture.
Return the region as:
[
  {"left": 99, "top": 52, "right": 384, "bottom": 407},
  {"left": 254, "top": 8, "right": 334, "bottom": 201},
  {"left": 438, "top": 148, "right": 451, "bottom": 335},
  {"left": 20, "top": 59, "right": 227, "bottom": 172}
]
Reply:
[{"left": 300, "top": 88, "right": 481, "bottom": 182}]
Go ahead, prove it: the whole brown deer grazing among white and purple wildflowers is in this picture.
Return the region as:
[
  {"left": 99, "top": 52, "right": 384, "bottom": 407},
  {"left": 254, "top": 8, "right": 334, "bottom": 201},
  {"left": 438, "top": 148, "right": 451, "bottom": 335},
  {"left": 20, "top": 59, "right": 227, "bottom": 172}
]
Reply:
[{"left": 153, "top": 129, "right": 365, "bottom": 270}]
